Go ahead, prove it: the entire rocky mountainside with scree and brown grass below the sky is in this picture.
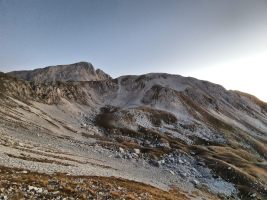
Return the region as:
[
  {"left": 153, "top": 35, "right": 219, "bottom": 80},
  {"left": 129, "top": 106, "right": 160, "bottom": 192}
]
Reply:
[{"left": 0, "top": 62, "right": 267, "bottom": 199}]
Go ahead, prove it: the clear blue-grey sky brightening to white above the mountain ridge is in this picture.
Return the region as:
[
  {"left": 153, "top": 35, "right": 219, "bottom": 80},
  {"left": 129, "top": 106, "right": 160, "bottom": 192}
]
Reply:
[{"left": 0, "top": 0, "right": 267, "bottom": 102}]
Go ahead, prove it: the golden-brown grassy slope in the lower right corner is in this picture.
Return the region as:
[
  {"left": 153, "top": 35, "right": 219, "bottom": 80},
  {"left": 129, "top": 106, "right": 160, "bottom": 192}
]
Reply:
[{"left": 191, "top": 146, "right": 267, "bottom": 199}]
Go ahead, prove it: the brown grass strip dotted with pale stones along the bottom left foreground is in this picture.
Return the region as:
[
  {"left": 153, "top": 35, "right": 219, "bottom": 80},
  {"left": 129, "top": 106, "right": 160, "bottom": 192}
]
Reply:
[{"left": 0, "top": 167, "right": 188, "bottom": 200}]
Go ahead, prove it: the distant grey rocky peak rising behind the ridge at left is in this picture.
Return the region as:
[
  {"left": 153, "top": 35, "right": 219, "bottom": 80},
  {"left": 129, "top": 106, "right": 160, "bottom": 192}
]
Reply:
[{"left": 8, "top": 62, "right": 111, "bottom": 83}]
